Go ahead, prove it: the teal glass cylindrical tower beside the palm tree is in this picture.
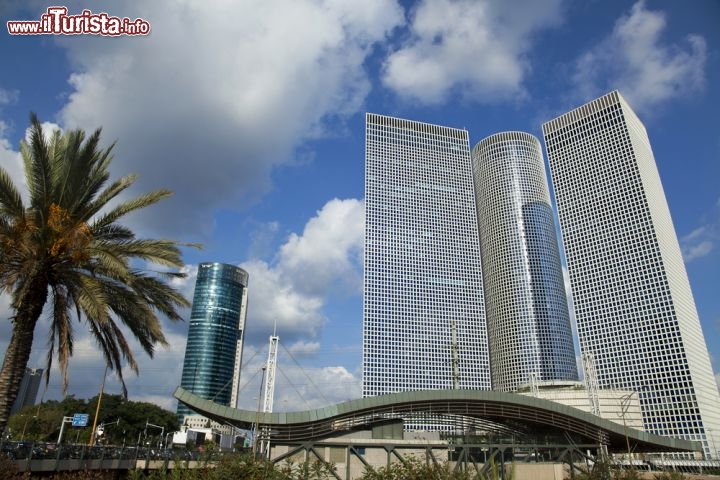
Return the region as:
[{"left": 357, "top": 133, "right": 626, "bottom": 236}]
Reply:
[{"left": 177, "top": 263, "right": 248, "bottom": 417}]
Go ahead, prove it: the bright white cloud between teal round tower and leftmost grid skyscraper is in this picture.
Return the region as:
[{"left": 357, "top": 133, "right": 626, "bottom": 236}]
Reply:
[{"left": 240, "top": 199, "right": 365, "bottom": 339}]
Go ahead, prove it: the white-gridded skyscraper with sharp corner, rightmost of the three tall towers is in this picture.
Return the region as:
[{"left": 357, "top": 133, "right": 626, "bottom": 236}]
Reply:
[{"left": 543, "top": 91, "right": 720, "bottom": 458}]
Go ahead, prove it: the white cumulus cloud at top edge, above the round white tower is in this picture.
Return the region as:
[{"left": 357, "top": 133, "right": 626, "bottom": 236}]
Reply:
[{"left": 383, "top": 0, "right": 562, "bottom": 104}]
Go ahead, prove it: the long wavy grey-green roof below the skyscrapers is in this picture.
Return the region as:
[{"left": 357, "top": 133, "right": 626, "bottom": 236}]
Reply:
[{"left": 174, "top": 387, "right": 701, "bottom": 452}]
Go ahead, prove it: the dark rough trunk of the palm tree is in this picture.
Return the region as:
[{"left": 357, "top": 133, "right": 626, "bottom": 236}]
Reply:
[{"left": 0, "top": 275, "right": 48, "bottom": 434}]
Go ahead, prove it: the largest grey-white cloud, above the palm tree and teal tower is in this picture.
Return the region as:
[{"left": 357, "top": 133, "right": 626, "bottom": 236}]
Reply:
[{"left": 45, "top": 0, "right": 403, "bottom": 236}]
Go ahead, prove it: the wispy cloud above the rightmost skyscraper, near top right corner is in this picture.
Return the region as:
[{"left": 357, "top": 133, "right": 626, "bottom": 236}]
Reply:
[{"left": 572, "top": 1, "right": 707, "bottom": 111}]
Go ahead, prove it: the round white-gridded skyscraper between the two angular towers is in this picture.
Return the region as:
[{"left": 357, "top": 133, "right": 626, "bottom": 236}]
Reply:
[{"left": 472, "top": 132, "right": 578, "bottom": 391}]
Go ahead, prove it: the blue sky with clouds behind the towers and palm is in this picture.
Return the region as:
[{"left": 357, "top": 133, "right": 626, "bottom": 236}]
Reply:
[{"left": 0, "top": 0, "right": 720, "bottom": 410}]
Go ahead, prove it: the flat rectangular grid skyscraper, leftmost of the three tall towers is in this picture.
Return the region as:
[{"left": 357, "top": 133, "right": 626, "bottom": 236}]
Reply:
[{"left": 363, "top": 114, "right": 490, "bottom": 397}]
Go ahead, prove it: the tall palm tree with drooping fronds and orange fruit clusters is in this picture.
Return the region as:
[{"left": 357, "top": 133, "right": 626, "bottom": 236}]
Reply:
[{"left": 0, "top": 113, "right": 197, "bottom": 432}]
